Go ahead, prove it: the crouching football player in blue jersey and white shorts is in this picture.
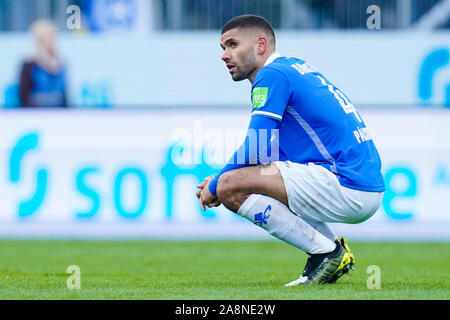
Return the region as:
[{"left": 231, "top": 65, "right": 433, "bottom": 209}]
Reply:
[{"left": 197, "top": 15, "right": 384, "bottom": 286}]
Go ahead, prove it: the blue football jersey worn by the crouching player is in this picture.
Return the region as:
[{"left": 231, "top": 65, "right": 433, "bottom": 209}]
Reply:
[{"left": 251, "top": 56, "right": 385, "bottom": 192}]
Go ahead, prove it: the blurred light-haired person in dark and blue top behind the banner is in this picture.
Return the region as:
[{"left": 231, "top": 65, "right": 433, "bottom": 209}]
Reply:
[{"left": 19, "top": 20, "right": 67, "bottom": 107}]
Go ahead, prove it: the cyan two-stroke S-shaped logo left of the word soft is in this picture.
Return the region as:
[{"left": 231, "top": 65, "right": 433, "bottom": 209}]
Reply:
[{"left": 9, "top": 133, "right": 48, "bottom": 217}]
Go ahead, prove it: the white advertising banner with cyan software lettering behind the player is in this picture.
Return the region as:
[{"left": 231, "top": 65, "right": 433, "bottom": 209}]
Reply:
[{"left": 0, "top": 108, "right": 450, "bottom": 240}]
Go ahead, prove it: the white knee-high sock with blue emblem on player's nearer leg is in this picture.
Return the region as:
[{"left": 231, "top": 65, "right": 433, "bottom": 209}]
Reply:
[{"left": 238, "top": 194, "right": 336, "bottom": 254}]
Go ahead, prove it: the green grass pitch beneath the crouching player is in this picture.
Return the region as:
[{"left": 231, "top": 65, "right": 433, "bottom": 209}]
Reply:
[{"left": 0, "top": 240, "right": 450, "bottom": 300}]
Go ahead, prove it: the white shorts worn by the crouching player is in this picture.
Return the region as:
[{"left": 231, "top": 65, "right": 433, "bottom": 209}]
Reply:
[{"left": 274, "top": 161, "right": 384, "bottom": 223}]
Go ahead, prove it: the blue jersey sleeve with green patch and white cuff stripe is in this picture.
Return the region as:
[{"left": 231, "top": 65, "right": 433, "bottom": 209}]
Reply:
[{"left": 252, "top": 67, "right": 293, "bottom": 121}]
